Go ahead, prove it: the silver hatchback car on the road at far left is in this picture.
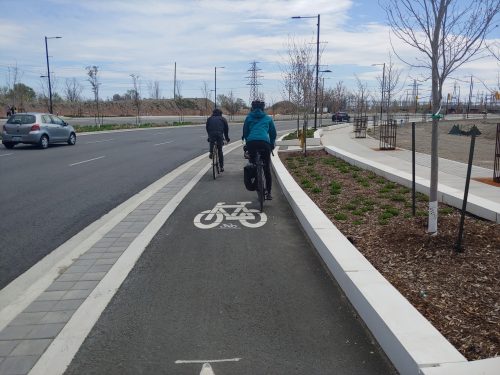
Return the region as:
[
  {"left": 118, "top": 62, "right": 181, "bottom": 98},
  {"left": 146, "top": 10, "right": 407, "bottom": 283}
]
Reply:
[{"left": 2, "top": 112, "right": 76, "bottom": 148}]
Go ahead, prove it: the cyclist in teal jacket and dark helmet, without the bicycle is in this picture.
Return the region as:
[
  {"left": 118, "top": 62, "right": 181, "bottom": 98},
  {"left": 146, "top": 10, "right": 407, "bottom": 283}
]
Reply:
[{"left": 242, "top": 100, "right": 276, "bottom": 200}]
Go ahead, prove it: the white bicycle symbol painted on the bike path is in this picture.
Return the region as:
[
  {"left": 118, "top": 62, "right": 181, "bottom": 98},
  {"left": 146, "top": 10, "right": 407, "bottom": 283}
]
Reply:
[{"left": 193, "top": 202, "right": 267, "bottom": 229}]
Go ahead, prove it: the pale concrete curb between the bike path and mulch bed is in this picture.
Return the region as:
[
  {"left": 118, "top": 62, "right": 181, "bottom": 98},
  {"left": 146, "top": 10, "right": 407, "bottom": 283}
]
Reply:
[{"left": 272, "top": 151, "right": 500, "bottom": 375}]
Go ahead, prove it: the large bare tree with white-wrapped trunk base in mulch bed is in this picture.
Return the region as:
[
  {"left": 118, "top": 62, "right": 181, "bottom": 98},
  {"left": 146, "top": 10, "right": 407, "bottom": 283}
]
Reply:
[{"left": 384, "top": 0, "right": 500, "bottom": 234}]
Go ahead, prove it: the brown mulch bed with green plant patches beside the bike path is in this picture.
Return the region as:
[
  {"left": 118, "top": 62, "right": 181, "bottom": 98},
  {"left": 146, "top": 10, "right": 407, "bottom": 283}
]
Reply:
[{"left": 280, "top": 151, "right": 500, "bottom": 360}]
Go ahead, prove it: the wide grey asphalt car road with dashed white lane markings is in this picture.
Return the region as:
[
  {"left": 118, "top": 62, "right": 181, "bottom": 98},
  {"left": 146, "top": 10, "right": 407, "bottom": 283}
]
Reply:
[{"left": 0, "top": 122, "right": 293, "bottom": 289}]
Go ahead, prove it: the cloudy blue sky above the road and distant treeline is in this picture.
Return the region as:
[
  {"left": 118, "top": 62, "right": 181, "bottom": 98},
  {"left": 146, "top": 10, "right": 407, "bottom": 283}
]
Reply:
[{"left": 0, "top": 0, "right": 500, "bottom": 106}]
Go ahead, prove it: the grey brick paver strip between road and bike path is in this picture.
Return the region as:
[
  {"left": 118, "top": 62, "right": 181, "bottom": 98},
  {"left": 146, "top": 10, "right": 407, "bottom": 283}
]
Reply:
[{"left": 0, "top": 154, "right": 206, "bottom": 375}]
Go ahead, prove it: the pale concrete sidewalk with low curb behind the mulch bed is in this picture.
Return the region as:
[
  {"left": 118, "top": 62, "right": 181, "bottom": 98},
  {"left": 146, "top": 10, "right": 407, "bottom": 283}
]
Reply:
[{"left": 321, "top": 126, "right": 500, "bottom": 223}]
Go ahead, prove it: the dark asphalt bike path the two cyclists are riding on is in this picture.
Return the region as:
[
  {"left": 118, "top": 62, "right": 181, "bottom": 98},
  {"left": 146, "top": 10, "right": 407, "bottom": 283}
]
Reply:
[{"left": 61, "top": 151, "right": 392, "bottom": 375}]
